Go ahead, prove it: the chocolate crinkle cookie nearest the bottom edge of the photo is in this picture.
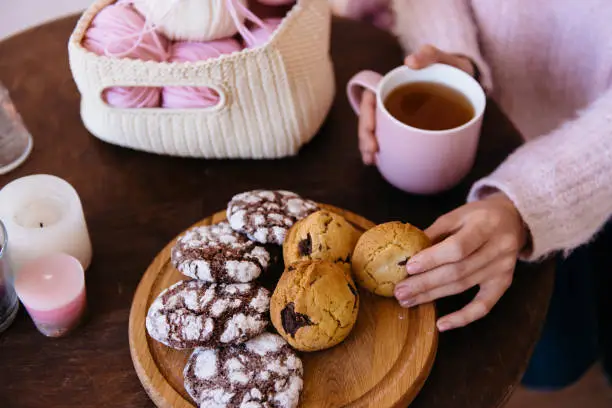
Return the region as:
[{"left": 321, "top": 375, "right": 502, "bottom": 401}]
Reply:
[{"left": 183, "top": 333, "right": 303, "bottom": 408}]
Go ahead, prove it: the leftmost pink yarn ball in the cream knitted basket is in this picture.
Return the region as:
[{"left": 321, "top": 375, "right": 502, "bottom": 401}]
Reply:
[{"left": 83, "top": 4, "right": 168, "bottom": 108}]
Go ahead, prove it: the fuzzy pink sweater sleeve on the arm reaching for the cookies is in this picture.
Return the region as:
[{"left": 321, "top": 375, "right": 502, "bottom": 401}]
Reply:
[{"left": 468, "top": 89, "right": 612, "bottom": 260}]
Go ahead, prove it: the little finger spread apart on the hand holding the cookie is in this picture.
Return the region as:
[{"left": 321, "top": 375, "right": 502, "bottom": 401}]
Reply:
[{"left": 437, "top": 271, "right": 512, "bottom": 331}]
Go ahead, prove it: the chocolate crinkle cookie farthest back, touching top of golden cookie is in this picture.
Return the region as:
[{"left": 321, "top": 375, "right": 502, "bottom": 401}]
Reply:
[{"left": 227, "top": 190, "right": 318, "bottom": 245}]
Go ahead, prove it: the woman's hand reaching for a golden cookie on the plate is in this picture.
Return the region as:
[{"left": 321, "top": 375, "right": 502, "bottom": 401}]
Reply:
[{"left": 395, "top": 193, "right": 528, "bottom": 331}]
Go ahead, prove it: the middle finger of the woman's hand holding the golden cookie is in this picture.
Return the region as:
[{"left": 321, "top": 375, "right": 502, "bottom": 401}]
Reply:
[{"left": 395, "top": 244, "right": 499, "bottom": 302}]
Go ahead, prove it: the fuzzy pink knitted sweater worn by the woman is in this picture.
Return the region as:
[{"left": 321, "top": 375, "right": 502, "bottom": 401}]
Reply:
[{"left": 331, "top": 0, "right": 612, "bottom": 260}]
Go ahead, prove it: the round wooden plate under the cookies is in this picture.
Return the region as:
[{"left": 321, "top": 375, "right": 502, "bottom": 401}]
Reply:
[{"left": 129, "top": 205, "right": 438, "bottom": 408}]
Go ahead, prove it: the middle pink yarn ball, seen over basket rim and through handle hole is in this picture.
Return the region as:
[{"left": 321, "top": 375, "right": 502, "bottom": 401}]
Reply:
[{"left": 162, "top": 38, "right": 242, "bottom": 108}]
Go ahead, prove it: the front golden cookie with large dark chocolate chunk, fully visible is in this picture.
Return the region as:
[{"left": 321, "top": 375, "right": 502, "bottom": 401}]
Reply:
[{"left": 270, "top": 260, "right": 359, "bottom": 351}]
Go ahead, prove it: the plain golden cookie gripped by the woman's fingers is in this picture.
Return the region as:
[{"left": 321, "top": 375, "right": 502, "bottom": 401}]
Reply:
[{"left": 352, "top": 221, "right": 431, "bottom": 297}]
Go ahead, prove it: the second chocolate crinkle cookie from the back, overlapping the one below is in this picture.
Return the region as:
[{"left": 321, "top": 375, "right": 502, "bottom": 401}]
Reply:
[{"left": 172, "top": 222, "right": 270, "bottom": 283}]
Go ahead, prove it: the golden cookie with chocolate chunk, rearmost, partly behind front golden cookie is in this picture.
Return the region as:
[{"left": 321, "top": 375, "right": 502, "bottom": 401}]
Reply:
[{"left": 283, "top": 210, "right": 360, "bottom": 269}]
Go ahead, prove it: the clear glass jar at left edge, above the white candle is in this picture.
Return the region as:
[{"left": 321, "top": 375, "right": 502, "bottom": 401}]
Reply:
[{"left": 0, "top": 82, "right": 33, "bottom": 174}]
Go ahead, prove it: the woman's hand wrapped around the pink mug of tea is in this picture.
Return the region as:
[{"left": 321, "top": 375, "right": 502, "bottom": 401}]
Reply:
[{"left": 359, "top": 45, "right": 474, "bottom": 166}]
